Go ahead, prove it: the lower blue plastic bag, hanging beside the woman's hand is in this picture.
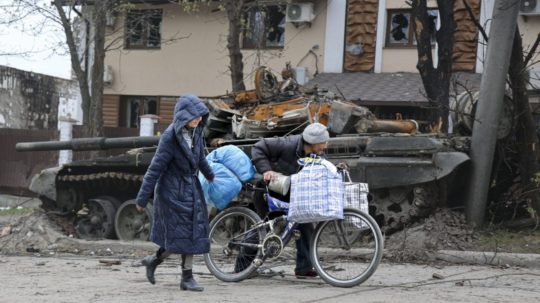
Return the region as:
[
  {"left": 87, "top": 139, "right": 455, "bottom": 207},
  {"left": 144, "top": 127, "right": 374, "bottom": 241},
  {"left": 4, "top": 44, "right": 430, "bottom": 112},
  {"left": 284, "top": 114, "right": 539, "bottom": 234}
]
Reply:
[{"left": 199, "top": 162, "right": 242, "bottom": 209}]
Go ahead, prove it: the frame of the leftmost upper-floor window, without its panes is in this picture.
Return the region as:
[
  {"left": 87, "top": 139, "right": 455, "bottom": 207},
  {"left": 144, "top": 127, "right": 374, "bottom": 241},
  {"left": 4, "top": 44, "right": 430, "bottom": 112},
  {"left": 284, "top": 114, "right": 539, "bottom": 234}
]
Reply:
[{"left": 124, "top": 9, "right": 163, "bottom": 50}]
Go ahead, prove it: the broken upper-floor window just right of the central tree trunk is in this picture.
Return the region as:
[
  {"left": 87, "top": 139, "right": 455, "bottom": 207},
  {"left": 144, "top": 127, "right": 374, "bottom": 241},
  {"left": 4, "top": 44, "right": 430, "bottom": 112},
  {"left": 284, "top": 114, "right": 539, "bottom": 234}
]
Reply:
[{"left": 242, "top": 5, "right": 285, "bottom": 49}]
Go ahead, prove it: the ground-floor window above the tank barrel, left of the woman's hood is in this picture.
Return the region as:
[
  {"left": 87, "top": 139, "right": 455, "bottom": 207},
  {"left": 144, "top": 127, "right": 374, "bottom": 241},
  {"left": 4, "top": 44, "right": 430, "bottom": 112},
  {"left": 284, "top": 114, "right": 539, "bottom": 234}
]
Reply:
[{"left": 120, "top": 96, "right": 159, "bottom": 128}]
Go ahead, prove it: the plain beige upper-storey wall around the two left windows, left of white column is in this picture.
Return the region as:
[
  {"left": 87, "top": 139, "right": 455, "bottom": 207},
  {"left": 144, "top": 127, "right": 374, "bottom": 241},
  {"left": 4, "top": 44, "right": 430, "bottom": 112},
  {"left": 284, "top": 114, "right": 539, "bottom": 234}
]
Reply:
[{"left": 105, "top": 1, "right": 326, "bottom": 96}]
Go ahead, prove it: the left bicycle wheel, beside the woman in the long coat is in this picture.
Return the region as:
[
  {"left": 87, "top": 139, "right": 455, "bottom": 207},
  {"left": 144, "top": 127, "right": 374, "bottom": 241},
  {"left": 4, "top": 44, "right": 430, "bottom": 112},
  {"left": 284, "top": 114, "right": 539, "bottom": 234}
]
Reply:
[{"left": 204, "top": 207, "right": 265, "bottom": 282}]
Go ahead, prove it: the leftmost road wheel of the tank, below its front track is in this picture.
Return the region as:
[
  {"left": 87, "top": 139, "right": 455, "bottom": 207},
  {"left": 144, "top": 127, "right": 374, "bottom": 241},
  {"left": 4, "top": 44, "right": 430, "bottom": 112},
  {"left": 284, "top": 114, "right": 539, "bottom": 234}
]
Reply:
[{"left": 75, "top": 199, "right": 116, "bottom": 239}]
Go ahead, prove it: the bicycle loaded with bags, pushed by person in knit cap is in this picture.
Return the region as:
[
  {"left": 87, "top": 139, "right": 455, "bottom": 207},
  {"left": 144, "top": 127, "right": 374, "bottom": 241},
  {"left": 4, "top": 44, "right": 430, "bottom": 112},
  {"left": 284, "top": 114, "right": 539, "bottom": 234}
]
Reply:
[{"left": 204, "top": 183, "right": 384, "bottom": 287}]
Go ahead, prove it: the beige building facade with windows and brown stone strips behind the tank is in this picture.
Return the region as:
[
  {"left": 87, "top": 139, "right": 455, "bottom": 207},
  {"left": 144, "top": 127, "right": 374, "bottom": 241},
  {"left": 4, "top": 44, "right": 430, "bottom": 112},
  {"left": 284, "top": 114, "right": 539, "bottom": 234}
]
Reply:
[{"left": 97, "top": 0, "right": 540, "bottom": 127}]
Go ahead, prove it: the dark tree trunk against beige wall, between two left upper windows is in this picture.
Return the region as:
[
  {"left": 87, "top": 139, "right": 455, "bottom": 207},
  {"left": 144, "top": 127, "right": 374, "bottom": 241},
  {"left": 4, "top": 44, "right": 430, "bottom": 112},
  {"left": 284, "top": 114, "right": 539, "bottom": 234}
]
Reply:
[{"left": 224, "top": 0, "right": 246, "bottom": 92}]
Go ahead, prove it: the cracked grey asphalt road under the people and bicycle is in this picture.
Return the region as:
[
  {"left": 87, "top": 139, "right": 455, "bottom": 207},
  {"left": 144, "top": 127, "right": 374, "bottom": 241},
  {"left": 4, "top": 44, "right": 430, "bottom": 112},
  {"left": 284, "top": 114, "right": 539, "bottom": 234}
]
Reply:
[{"left": 0, "top": 255, "right": 540, "bottom": 303}]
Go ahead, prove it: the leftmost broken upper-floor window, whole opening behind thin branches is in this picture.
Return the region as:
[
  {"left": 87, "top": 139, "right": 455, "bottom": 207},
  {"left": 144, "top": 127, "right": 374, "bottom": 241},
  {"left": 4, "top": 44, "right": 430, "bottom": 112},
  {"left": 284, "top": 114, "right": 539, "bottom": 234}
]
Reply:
[{"left": 126, "top": 9, "right": 162, "bottom": 49}]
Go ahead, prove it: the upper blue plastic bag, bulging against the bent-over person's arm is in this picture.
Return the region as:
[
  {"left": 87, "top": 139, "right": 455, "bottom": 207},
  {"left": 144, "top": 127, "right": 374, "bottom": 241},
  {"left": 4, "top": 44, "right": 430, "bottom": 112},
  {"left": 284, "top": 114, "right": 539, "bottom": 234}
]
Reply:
[{"left": 206, "top": 145, "right": 255, "bottom": 182}]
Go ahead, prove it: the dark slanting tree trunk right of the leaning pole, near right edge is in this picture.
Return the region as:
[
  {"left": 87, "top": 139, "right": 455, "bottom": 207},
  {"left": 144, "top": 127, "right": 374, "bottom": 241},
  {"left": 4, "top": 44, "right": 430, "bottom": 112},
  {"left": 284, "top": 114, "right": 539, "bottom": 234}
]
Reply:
[{"left": 508, "top": 28, "right": 540, "bottom": 216}]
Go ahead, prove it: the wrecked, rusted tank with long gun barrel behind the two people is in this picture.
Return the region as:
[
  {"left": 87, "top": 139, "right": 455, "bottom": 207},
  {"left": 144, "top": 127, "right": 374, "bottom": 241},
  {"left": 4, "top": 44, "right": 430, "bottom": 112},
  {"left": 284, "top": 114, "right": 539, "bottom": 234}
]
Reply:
[{"left": 12, "top": 66, "right": 470, "bottom": 240}]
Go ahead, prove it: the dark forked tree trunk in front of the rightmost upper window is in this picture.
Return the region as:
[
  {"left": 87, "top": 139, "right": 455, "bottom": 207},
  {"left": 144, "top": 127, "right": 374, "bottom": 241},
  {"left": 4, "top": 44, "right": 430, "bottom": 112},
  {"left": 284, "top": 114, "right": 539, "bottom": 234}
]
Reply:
[{"left": 412, "top": 0, "right": 455, "bottom": 132}]
